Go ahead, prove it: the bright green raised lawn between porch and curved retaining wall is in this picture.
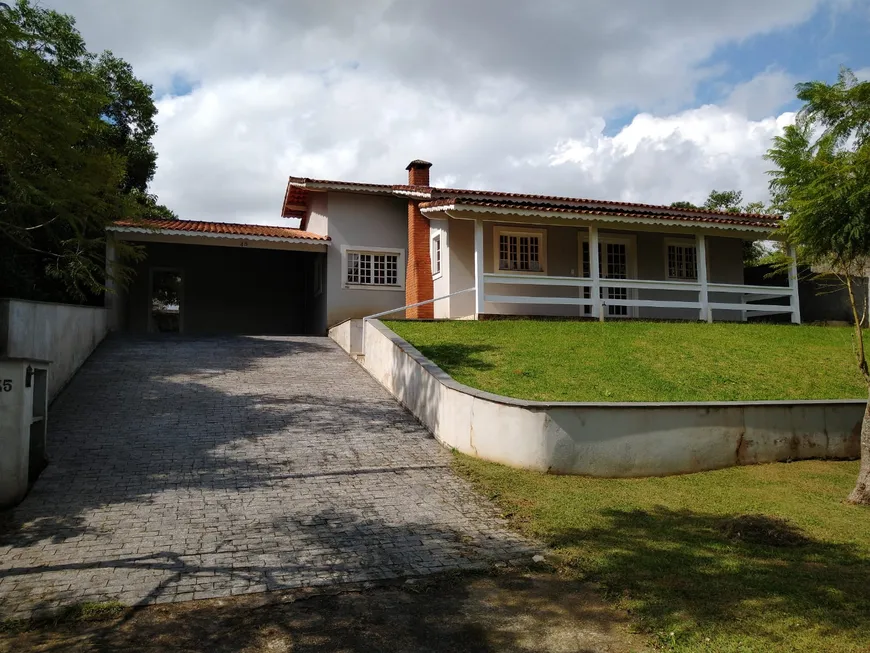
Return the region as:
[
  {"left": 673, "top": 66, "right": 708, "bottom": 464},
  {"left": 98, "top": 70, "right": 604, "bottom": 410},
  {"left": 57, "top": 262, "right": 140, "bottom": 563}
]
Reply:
[{"left": 388, "top": 320, "right": 867, "bottom": 401}]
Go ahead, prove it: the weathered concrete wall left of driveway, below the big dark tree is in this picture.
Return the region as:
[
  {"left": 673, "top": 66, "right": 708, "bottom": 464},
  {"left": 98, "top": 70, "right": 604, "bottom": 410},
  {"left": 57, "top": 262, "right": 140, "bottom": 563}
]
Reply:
[{"left": 0, "top": 299, "right": 108, "bottom": 400}]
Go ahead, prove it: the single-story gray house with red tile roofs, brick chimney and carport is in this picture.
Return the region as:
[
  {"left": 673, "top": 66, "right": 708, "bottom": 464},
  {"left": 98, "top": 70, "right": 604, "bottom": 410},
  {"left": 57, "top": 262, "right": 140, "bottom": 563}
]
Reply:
[{"left": 107, "top": 160, "right": 800, "bottom": 334}]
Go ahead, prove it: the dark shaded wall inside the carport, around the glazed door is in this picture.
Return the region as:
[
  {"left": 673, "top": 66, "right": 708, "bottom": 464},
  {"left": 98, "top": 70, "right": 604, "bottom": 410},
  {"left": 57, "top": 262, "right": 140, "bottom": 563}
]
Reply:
[{"left": 119, "top": 243, "right": 326, "bottom": 335}]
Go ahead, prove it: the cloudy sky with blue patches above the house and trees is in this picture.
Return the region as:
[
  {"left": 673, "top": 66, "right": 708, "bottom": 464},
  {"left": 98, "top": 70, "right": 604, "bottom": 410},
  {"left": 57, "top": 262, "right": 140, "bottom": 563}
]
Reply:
[{"left": 41, "top": 0, "right": 870, "bottom": 224}]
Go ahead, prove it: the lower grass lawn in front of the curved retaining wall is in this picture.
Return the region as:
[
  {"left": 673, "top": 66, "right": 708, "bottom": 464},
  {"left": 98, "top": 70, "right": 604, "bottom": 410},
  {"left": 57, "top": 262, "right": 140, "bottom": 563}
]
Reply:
[{"left": 455, "top": 454, "right": 870, "bottom": 653}]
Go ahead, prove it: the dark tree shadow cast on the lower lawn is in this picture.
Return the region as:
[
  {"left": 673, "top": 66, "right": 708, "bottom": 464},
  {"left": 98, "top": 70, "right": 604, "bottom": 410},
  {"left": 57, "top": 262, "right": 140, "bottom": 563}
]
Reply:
[{"left": 548, "top": 507, "right": 870, "bottom": 650}]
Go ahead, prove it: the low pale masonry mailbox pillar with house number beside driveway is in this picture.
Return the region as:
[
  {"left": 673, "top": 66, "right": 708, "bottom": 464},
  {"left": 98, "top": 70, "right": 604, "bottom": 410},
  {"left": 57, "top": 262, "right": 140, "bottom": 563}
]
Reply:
[{"left": 0, "top": 357, "right": 49, "bottom": 508}]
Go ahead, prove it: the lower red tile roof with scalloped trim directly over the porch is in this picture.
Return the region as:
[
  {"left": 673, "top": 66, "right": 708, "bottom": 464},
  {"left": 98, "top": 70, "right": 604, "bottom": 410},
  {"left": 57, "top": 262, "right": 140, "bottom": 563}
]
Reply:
[{"left": 420, "top": 197, "right": 780, "bottom": 230}]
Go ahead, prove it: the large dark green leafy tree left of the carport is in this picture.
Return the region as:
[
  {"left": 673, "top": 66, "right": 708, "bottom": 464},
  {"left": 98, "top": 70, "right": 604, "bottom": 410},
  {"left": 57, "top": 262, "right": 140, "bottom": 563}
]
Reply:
[{"left": 0, "top": 0, "right": 168, "bottom": 301}]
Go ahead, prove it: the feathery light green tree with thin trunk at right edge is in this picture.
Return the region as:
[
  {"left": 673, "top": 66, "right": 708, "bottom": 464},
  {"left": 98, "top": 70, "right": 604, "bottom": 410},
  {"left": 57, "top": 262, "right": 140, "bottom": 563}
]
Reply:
[{"left": 766, "top": 68, "right": 870, "bottom": 505}]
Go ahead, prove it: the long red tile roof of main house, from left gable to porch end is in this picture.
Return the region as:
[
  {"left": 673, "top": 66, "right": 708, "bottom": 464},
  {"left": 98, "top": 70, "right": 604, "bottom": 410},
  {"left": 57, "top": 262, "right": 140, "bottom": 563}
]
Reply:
[{"left": 282, "top": 177, "right": 782, "bottom": 229}]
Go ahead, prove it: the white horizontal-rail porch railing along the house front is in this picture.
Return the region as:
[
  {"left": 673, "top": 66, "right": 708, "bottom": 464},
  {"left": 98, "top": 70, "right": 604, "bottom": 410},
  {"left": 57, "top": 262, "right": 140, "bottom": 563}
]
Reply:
[{"left": 483, "top": 273, "right": 800, "bottom": 323}]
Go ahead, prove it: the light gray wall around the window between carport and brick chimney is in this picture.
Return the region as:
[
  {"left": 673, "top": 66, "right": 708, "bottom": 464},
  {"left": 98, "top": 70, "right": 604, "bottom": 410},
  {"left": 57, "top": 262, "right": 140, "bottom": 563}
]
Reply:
[{"left": 326, "top": 192, "right": 408, "bottom": 326}]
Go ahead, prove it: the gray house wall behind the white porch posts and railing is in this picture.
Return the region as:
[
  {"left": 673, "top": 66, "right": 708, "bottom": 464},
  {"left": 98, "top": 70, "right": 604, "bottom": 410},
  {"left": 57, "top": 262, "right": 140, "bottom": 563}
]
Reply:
[{"left": 449, "top": 219, "right": 743, "bottom": 320}]
